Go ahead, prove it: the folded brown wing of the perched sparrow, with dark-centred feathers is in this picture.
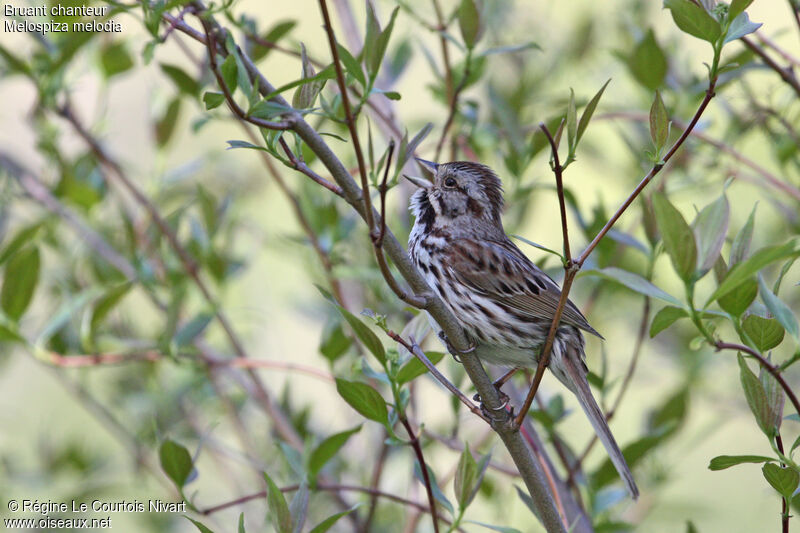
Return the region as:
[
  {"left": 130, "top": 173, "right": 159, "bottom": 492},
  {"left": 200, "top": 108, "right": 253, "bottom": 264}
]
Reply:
[{"left": 445, "top": 239, "right": 603, "bottom": 338}]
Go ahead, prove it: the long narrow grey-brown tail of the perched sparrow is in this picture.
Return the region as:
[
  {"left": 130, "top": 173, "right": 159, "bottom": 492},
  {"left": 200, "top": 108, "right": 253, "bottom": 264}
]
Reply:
[{"left": 559, "top": 354, "right": 639, "bottom": 500}]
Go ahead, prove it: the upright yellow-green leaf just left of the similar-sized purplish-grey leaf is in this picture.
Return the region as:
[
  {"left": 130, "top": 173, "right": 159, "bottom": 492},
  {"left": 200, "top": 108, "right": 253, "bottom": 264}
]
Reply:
[{"left": 653, "top": 192, "right": 697, "bottom": 283}]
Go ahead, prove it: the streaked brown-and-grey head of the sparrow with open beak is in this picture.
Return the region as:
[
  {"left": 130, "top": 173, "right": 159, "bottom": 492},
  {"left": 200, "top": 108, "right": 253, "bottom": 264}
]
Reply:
[{"left": 405, "top": 158, "right": 503, "bottom": 227}]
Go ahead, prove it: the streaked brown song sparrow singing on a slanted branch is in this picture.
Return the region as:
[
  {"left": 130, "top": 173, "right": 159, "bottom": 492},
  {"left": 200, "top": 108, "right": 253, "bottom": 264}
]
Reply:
[{"left": 406, "top": 160, "right": 639, "bottom": 498}]
